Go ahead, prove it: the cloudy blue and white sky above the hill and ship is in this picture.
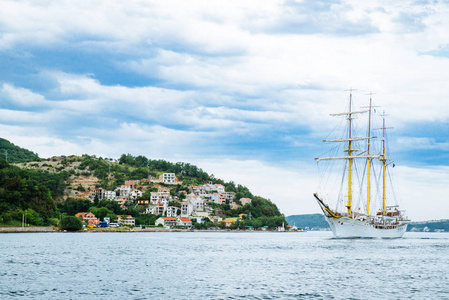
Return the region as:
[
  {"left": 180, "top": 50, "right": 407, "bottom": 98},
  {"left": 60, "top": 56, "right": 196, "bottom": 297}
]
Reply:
[{"left": 0, "top": 0, "right": 449, "bottom": 220}]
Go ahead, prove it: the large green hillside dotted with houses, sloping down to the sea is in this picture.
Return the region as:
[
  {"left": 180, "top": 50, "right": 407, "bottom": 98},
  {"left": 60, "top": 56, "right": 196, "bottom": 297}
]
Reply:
[{"left": 0, "top": 139, "right": 286, "bottom": 229}]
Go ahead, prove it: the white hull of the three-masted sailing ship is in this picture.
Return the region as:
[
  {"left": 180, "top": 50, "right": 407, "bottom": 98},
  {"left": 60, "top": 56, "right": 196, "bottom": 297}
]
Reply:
[{"left": 324, "top": 216, "right": 407, "bottom": 238}]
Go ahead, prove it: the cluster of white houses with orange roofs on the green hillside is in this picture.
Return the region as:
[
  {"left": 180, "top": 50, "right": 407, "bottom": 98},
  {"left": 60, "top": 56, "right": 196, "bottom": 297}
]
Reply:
[{"left": 70, "top": 173, "right": 292, "bottom": 231}]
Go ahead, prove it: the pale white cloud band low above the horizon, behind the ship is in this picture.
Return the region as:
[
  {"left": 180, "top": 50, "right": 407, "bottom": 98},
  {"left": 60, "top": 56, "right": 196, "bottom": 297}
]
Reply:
[{"left": 195, "top": 159, "right": 449, "bottom": 221}]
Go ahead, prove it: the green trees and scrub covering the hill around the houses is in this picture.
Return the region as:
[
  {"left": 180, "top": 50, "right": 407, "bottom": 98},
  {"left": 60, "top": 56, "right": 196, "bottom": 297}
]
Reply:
[{"left": 0, "top": 140, "right": 286, "bottom": 228}]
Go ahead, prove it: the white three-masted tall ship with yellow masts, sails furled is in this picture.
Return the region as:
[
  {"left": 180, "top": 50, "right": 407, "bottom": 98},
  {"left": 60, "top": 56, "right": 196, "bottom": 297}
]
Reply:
[{"left": 314, "top": 90, "right": 410, "bottom": 238}]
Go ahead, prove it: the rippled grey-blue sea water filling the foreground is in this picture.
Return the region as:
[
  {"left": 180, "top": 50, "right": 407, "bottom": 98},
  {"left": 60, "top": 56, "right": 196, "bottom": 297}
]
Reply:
[{"left": 0, "top": 232, "right": 449, "bottom": 299}]
